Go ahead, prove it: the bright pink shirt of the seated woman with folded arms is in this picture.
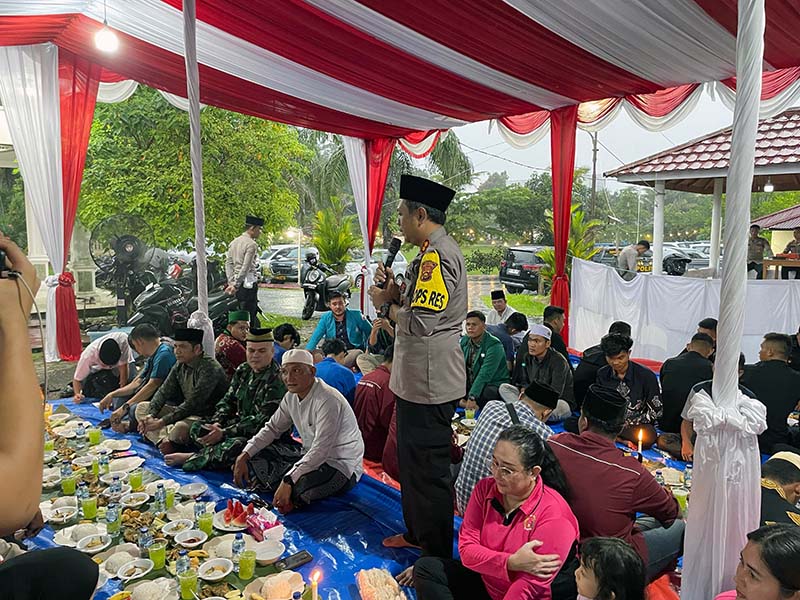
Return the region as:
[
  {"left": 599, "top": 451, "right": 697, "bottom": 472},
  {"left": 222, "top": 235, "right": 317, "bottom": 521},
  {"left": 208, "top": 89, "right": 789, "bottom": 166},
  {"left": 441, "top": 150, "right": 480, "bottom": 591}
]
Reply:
[{"left": 458, "top": 477, "right": 578, "bottom": 600}]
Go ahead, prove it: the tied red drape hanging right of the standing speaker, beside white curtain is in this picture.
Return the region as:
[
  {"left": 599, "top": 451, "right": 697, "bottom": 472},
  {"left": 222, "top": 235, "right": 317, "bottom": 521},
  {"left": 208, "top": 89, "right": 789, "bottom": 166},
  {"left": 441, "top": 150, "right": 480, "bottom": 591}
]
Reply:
[{"left": 550, "top": 105, "right": 578, "bottom": 343}]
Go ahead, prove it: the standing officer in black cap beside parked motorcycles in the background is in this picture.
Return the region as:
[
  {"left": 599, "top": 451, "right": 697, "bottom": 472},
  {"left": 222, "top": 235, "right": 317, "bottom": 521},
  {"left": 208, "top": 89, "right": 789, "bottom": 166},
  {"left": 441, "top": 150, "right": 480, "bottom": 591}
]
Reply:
[{"left": 225, "top": 216, "right": 264, "bottom": 329}]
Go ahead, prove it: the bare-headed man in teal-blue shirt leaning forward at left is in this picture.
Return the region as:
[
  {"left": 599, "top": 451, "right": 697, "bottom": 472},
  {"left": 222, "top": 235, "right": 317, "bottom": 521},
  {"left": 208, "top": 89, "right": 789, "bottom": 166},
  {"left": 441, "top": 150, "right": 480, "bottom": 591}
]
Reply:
[{"left": 100, "top": 323, "right": 175, "bottom": 433}]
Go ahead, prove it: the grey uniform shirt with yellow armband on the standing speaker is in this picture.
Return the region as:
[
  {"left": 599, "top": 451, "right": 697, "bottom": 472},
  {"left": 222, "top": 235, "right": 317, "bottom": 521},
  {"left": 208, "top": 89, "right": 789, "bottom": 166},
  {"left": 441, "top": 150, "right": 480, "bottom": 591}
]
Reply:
[{"left": 389, "top": 227, "right": 467, "bottom": 404}]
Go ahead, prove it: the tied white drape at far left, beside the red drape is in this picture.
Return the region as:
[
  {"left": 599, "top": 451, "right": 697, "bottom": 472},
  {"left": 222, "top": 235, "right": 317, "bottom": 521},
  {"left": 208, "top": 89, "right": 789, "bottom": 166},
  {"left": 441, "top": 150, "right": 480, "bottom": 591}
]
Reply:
[{"left": 0, "top": 44, "right": 64, "bottom": 361}]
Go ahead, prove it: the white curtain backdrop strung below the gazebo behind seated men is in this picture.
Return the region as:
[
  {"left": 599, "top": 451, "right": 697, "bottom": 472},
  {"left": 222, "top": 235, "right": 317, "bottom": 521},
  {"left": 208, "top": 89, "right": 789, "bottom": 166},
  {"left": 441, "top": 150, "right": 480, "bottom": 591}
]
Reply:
[{"left": 569, "top": 259, "right": 800, "bottom": 363}]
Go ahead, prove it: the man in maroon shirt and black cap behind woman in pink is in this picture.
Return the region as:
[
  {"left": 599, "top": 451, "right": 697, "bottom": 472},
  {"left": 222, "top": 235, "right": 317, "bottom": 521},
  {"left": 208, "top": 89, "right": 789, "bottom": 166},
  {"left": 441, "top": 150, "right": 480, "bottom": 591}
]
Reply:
[{"left": 547, "top": 384, "right": 685, "bottom": 581}]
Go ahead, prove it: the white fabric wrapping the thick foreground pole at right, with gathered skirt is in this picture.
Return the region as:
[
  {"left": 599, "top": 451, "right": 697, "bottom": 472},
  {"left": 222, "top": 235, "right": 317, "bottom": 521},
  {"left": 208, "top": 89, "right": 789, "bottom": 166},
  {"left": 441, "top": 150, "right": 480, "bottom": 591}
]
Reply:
[{"left": 681, "top": 0, "right": 768, "bottom": 600}]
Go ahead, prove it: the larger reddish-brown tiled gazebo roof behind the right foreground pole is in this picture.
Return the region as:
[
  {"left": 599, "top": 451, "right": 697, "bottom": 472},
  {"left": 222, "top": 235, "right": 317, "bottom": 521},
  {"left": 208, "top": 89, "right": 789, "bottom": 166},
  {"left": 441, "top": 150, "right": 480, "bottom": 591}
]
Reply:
[{"left": 605, "top": 109, "right": 800, "bottom": 194}]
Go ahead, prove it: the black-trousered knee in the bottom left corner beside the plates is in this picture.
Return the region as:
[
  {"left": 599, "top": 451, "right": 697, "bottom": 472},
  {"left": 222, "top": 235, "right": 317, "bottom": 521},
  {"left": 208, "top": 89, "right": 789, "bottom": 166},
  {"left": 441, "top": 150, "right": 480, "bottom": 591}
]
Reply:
[{"left": 0, "top": 548, "right": 98, "bottom": 600}]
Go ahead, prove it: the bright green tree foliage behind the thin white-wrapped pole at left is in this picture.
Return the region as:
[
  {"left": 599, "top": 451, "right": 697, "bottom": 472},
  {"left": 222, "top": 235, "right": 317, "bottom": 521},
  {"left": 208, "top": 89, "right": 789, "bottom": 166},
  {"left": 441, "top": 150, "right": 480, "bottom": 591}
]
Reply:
[{"left": 78, "top": 88, "right": 310, "bottom": 251}]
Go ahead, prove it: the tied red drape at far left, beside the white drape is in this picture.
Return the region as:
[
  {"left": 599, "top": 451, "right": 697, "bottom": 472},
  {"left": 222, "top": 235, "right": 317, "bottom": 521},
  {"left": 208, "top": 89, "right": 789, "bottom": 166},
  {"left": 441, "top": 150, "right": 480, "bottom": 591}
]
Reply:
[{"left": 54, "top": 49, "right": 101, "bottom": 361}]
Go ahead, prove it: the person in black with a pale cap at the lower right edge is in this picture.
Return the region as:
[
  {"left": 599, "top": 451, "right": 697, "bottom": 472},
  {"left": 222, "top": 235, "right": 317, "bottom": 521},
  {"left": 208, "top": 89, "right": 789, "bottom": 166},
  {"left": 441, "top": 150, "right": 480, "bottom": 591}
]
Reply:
[{"left": 761, "top": 452, "right": 800, "bottom": 525}]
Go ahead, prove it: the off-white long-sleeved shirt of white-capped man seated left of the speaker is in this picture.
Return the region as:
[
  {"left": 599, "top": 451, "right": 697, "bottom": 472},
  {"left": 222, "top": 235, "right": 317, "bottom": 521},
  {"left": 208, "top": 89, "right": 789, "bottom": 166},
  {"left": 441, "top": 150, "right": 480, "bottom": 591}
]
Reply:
[{"left": 244, "top": 378, "right": 364, "bottom": 483}]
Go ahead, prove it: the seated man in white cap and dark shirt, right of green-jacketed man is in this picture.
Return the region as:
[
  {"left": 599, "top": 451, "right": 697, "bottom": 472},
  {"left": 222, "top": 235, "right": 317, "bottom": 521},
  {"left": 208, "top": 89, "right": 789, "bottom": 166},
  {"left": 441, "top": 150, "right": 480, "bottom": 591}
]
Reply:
[{"left": 511, "top": 325, "right": 575, "bottom": 421}]
